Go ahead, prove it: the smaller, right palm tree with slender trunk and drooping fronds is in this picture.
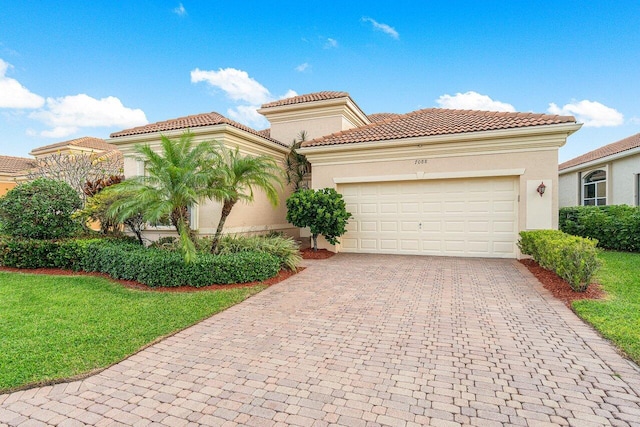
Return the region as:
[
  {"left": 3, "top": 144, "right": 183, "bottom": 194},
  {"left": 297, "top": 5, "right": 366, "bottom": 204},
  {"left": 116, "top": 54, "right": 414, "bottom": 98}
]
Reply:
[{"left": 210, "top": 146, "right": 282, "bottom": 253}]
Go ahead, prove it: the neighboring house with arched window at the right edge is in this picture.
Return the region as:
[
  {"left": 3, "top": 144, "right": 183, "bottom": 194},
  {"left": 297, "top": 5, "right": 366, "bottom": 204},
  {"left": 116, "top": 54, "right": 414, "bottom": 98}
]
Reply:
[{"left": 558, "top": 133, "right": 640, "bottom": 207}]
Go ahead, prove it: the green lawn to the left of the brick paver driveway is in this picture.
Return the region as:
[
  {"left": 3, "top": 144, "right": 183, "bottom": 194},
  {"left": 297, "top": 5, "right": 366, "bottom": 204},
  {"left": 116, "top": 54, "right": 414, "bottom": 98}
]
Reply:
[{"left": 0, "top": 272, "right": 264, "bottom": 392}]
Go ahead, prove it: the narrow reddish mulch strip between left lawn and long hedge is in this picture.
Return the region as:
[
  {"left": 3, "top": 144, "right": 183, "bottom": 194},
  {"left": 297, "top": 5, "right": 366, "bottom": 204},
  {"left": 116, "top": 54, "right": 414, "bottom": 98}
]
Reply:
[{"left": 0, "top": 267, "right": 304, "bottom": 292}]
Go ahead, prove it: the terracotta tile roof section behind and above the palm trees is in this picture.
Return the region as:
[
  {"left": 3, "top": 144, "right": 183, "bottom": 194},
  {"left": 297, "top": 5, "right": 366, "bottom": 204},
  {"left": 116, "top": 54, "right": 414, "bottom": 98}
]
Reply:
[{"left": 110, "top": 111, "right": 284, "bottom": 145}]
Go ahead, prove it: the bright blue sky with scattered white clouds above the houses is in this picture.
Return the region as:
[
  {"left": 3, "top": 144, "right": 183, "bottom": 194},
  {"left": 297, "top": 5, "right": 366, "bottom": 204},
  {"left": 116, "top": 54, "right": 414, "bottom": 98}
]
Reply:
[{"left": 0, "top": 0, "right": 640, "bottom": 161}]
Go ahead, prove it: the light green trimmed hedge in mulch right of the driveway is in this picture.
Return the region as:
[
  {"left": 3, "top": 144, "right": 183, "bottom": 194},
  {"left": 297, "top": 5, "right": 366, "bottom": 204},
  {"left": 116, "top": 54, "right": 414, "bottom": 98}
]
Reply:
[{"left": 518, "top": 230, "right": 600, "bottom": 292}]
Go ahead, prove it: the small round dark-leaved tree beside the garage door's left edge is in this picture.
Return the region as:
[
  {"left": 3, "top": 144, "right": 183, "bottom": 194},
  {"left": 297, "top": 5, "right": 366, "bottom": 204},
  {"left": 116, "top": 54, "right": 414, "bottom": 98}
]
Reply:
[{"left": 287, "top": 188, "right": 351, "bottom": 251}]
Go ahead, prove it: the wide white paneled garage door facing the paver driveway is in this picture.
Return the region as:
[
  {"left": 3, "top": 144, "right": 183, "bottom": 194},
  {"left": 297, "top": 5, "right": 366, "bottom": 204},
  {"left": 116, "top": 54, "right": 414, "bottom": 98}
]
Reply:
[{"left": 338, "top": 177, "right": 518, "bottom": 258}]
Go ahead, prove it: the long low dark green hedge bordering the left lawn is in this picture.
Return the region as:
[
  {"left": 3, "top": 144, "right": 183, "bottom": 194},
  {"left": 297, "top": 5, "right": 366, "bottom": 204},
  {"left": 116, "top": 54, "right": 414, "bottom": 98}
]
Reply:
[{"left": 0, "top": 238, "right": 281, "bottom": 287}]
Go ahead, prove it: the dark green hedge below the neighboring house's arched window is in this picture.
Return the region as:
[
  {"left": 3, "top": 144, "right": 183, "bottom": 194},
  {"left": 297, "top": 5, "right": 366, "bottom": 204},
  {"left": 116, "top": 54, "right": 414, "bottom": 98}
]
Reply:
[{"left": 560, "top": 205, "right": 640, "bottom": 252}]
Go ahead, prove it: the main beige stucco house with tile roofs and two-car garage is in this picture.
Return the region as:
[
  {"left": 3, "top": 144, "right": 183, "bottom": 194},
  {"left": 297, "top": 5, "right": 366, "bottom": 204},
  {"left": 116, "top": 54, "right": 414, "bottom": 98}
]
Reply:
[{"left": 109, "top": 92, "right": 581, "bottom": 258}]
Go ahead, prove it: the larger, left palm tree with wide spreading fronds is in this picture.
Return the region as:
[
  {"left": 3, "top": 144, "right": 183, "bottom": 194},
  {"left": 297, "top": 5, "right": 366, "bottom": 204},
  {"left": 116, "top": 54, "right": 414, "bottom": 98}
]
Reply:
[{"left": 104, "top": 132, "right": 220, "bottom": 262}]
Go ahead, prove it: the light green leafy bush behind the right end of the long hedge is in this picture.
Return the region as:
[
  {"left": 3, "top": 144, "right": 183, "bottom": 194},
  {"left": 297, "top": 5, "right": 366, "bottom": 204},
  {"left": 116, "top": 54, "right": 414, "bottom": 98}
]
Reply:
[{"left": 218, "top": 235, "right": 302, "bottom": 271}]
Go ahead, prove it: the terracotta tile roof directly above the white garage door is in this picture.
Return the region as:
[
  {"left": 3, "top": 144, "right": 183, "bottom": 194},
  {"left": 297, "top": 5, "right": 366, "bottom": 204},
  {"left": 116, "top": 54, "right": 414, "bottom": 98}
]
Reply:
[{"left": 302, "top": 108, "right": 576, "bottom": 147}]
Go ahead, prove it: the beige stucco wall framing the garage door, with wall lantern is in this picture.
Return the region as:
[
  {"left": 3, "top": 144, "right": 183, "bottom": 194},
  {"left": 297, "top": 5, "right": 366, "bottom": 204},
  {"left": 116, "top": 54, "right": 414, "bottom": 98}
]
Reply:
[{"left": 302, "top": 124, "right": 580, "bottom": 254}]
